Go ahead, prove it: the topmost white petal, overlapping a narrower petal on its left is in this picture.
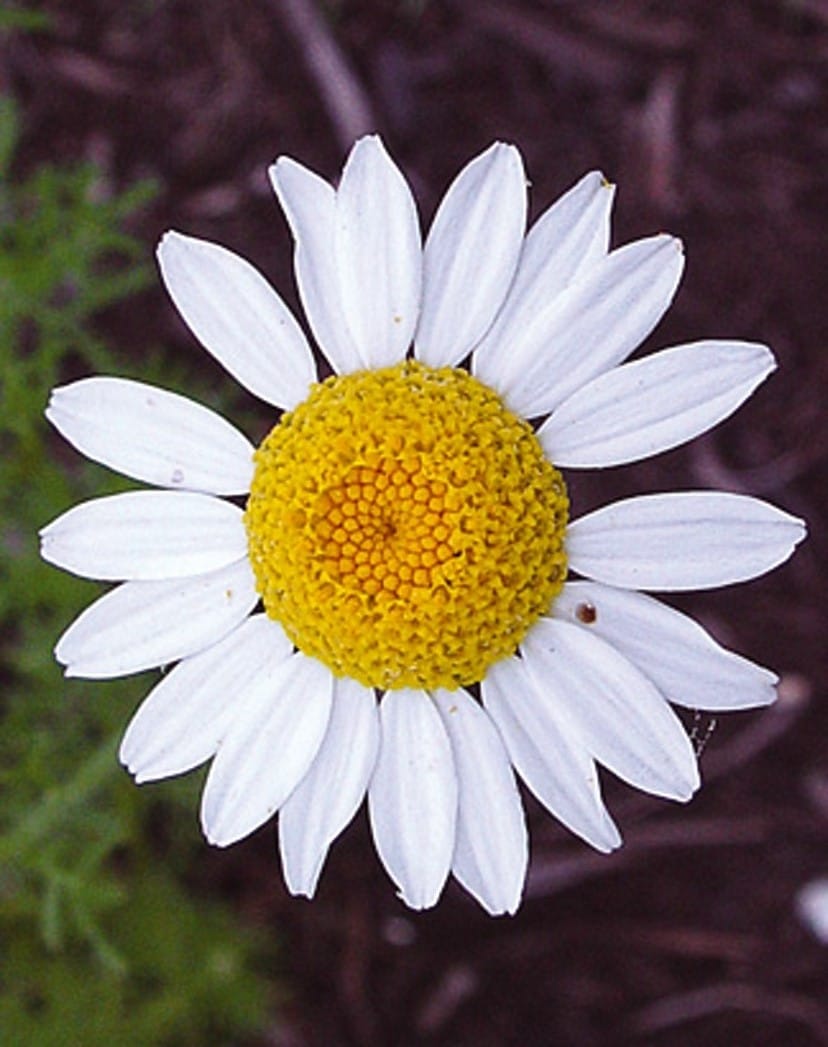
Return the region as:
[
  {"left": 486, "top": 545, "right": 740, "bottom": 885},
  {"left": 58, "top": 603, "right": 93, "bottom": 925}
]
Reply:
[{"left": 335, "top": 135, "right": 422, "bottom": 367}]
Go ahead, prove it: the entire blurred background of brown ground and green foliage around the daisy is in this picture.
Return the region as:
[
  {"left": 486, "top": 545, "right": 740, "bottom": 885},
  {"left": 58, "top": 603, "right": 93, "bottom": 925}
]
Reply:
[{"left": 0, "top": 0, "right": 828, "bottom": 1047}]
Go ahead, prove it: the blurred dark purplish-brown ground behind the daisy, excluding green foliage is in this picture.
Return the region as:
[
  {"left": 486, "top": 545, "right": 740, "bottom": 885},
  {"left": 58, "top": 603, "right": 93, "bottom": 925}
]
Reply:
[{"left": 0, "top": 0, "right": 828, "bottom": 1047}]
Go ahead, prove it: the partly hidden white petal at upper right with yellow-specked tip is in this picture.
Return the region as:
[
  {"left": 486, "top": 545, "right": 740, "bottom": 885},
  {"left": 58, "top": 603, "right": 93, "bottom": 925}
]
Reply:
[{"left": 472, "top": 171, "right": 614, "bottom": 388}]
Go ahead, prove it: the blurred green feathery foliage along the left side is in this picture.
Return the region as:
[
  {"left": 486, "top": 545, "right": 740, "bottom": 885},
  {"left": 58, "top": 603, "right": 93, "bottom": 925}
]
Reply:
[{"left": 0, "top": 98, "right": 272, "bottom": 1047}]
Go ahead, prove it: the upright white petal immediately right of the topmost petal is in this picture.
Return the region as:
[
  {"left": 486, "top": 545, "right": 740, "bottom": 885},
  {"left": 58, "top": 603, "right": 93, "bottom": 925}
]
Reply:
[{"left": 417, "top": 142, "right": 527, "bottom": 367}]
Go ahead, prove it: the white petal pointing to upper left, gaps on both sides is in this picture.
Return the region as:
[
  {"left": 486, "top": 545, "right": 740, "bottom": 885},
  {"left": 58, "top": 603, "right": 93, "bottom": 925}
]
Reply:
[{"left": 158, "top": 232, "right": 316, "bottom": 408}]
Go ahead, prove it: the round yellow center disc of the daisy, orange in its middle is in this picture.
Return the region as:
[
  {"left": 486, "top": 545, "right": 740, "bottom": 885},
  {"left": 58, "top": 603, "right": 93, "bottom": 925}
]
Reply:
[{"left": 245, "top": 360, "right": 568, "bottom": 689}]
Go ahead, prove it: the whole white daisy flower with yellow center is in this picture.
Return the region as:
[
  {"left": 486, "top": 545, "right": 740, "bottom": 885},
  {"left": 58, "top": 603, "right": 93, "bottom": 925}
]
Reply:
[{"left": 42, "top": 136, "right": 805, "bottom": 914}]
